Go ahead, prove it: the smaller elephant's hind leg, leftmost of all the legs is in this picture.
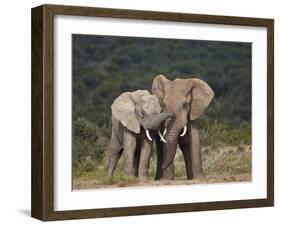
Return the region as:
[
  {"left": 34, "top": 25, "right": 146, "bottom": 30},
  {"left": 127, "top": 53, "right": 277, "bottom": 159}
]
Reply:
[{"left": 107, "top": 131, "right": 123, "bottom": 176}]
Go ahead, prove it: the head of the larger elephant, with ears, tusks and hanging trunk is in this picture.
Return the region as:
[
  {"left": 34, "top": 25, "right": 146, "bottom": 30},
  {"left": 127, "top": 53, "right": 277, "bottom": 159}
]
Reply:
[{"left": 152, "top": 75, "right": 214, "bottom": 169}]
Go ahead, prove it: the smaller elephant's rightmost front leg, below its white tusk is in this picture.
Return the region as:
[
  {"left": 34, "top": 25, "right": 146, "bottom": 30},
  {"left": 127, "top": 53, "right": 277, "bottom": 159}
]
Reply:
[{"left": 139, "top": 139, "right": 152, "bottom": 179}]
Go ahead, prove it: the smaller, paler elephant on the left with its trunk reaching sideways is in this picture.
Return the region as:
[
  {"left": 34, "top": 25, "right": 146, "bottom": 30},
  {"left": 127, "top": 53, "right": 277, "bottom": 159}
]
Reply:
[{"left": 107, "top": 90, "right": 174, "bottom": 179}]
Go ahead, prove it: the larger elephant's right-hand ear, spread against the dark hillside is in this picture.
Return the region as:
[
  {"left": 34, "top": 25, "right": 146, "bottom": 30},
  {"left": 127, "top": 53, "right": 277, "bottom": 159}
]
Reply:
[{"left": 190, "top": 79, "right": 214, "bottom": 120}]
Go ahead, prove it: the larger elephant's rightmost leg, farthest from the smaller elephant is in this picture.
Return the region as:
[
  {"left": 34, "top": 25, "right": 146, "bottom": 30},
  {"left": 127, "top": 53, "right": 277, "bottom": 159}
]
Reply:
[{"left": 188, "top": 122, "right": 203, "bottom": 178}]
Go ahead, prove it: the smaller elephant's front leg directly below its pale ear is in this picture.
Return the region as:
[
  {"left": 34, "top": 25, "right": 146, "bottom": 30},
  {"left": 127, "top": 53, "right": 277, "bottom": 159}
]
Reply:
[{"left": 123, "top": 129, "right": 136, "bottom": 176}]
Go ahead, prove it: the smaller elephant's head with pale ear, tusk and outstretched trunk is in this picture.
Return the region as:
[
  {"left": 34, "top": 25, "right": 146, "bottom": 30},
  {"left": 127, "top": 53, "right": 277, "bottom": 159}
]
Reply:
[{"left": 111, "top": 90, "right": 174, "bottom": 141}]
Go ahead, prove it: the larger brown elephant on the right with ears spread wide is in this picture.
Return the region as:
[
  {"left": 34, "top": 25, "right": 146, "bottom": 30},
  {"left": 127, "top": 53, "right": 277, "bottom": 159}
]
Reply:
[{"left": 152, "top": 75, "right": 214, "bottom": 180}]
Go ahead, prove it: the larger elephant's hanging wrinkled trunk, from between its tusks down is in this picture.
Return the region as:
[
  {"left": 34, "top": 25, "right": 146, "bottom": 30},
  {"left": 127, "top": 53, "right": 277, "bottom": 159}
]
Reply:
[{"left": 162, "top": 128, "right": 181, "bottom": 169}]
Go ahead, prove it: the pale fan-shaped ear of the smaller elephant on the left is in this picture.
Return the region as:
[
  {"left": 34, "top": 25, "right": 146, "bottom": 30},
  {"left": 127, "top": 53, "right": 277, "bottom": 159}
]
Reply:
[{"left": 111, "top": 92, "right": 140, "bottom": 133}]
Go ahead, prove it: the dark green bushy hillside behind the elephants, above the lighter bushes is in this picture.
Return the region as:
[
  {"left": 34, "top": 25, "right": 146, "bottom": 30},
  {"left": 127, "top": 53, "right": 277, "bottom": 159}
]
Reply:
[{"left": 72, "top": 34, "right": 249, "bottom": 128}]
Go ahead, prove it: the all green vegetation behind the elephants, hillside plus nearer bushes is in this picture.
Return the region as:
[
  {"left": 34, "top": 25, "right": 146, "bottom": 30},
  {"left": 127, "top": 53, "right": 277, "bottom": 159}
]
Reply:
[{"left": 72, "top": 35, "right": 251, "bottom": 187}]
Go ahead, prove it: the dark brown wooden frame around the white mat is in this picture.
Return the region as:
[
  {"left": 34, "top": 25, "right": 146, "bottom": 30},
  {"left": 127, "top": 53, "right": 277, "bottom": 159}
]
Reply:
[{"left": 31, "top": 5, "right": 274, "bottom": 221}]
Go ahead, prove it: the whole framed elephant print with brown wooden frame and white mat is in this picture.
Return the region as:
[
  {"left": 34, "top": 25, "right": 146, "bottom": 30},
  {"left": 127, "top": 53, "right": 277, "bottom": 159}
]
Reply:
[{"left": 31, "top": 5, "right": 274, "bottom": 221}]
